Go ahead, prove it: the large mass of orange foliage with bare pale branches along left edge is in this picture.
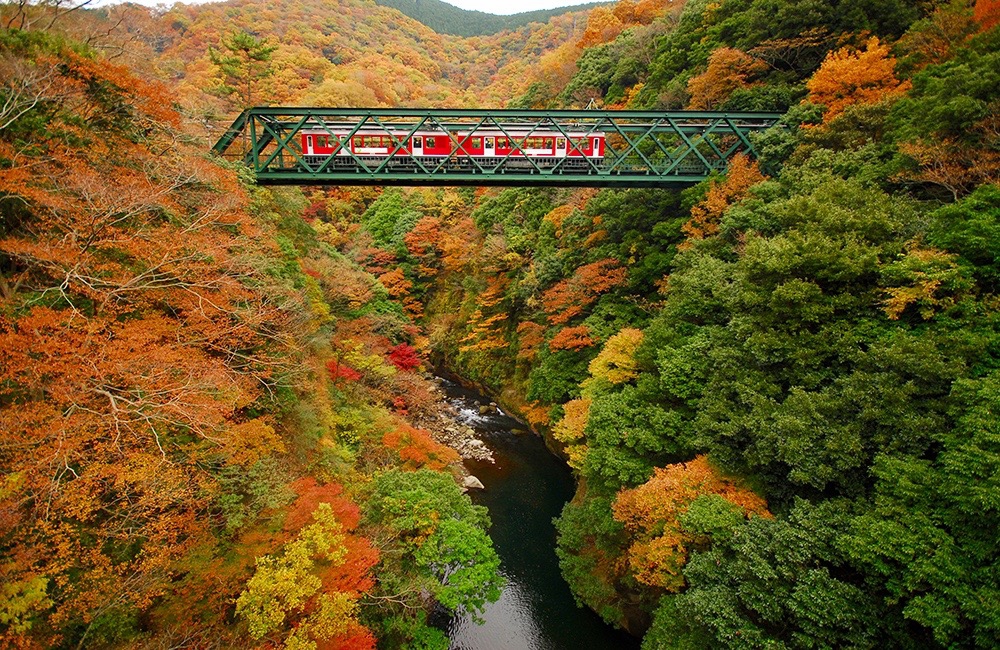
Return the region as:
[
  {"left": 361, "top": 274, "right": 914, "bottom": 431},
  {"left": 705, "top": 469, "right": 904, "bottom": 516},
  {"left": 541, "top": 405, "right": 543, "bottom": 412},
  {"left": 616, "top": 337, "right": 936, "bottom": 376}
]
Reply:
[{"left": 0, "top": 41, "right": 316, "bottom": 646}]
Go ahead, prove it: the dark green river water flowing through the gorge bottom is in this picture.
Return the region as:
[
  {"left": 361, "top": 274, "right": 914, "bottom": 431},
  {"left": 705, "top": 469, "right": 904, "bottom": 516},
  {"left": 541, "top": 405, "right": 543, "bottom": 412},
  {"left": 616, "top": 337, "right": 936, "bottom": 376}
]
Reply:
[{"left": 444, "top": 382, "right": 639, "bottom": 650}]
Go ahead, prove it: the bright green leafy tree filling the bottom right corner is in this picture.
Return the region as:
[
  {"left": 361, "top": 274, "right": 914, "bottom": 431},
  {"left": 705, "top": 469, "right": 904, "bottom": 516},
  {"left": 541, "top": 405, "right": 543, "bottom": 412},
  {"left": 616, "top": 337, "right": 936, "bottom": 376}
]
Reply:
[{"left": 840, "top": 372, "right": 1000, "bottom": 648}]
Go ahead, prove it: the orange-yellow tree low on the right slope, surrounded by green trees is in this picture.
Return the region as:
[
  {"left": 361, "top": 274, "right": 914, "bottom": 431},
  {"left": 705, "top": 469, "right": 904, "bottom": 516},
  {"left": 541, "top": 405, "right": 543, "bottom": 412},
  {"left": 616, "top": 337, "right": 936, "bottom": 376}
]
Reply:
[{"left": 612, "top": 456, "right": 770, "bottom": 592}]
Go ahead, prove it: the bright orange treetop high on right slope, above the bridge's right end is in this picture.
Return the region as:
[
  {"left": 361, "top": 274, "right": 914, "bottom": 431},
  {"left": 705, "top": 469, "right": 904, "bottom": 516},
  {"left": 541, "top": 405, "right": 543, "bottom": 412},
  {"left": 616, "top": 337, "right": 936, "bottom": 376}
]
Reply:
[{"left": 806, "top": 37, "right": 910, "bottom": 122}]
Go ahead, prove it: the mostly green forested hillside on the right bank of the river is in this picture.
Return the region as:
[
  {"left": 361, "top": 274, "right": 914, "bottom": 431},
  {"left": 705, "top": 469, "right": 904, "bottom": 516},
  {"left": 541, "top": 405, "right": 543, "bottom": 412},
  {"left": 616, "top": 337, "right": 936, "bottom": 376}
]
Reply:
[{"left": 292, "top": 0, "right": 1000, "bottom": 649}]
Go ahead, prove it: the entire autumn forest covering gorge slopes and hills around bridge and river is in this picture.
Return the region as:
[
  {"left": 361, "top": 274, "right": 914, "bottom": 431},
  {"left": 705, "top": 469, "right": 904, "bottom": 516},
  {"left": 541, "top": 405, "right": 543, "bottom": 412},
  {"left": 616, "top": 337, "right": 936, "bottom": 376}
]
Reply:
[{"left": 0, "top": 0, "right": 1000, "bottom": 650}]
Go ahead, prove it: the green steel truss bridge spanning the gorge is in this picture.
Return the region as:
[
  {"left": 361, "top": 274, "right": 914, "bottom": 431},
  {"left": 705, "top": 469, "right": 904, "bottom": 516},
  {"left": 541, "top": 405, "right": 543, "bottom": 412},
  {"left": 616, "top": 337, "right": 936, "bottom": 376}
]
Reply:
[{"left": 212, "top": 107, "right": 781, "bottom": 187}]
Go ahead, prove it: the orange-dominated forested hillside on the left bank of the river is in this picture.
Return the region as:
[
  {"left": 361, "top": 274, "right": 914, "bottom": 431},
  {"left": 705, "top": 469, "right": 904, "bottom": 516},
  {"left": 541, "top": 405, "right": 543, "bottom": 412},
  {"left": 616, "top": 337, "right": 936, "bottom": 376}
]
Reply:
[{"left": 0, "top": 12, "right": 502, "bottom": 648}]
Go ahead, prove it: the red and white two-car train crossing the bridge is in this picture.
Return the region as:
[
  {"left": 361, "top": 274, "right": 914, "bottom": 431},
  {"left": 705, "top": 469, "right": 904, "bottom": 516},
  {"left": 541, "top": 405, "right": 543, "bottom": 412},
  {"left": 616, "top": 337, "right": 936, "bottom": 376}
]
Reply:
[{"left": 301, "top": 128, "right": 605, "bottom": 171}]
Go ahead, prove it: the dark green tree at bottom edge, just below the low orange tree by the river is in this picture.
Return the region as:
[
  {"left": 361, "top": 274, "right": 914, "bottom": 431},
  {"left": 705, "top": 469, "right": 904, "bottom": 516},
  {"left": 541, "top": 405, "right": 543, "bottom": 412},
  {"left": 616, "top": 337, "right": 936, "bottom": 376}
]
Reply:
[{"left": 643, "top": 501, "right": 893, "bottom": 650}]
